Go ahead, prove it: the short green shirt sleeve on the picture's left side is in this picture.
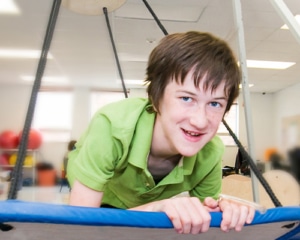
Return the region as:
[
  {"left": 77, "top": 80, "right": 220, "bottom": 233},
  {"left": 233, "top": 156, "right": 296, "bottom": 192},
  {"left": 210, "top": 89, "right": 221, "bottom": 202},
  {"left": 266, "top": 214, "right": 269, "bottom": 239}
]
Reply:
[{"left": 68, "top": 113, "right": 122, "bottom": 191}]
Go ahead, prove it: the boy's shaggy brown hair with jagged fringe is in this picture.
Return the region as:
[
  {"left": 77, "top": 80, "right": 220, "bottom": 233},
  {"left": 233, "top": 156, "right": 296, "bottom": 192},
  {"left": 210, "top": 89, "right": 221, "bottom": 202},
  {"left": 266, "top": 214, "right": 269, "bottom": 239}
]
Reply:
[{"left": 145, "top": 31, "right": 241, "bottom": 112}]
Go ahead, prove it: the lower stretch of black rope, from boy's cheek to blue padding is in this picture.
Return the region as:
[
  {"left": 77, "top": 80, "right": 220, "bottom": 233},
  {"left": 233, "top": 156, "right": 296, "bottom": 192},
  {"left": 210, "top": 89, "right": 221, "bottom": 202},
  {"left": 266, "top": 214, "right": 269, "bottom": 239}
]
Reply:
[{"left": 222, "top": 119, "right": 282, "bottom": 207}]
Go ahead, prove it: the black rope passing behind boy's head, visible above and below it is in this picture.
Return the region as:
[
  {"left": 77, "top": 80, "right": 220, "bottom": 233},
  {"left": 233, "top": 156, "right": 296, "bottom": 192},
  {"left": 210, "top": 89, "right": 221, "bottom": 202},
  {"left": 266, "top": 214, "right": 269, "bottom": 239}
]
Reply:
[{"left": 143, "top": 0, "right": 282, "bottom": 207}]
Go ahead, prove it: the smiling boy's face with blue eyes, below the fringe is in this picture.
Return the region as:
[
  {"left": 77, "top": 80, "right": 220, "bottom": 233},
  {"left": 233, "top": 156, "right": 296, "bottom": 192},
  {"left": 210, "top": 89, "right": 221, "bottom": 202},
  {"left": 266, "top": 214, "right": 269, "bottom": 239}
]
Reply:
[{"left": 152, "top": 71, "right": 227, "bottom": 156}]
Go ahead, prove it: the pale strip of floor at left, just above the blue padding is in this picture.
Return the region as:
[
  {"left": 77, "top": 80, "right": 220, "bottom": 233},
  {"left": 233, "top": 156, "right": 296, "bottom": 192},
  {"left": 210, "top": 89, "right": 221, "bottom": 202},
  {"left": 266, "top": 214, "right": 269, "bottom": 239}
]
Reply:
[{"left": 0, "top": 186, "right": 70, "bottom": 204}]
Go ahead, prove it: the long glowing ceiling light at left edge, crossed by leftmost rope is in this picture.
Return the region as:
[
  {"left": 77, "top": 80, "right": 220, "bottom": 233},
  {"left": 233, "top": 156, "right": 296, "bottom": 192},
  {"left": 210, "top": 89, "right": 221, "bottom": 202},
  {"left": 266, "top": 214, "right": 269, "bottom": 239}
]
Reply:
[{"left": 0, "top": 49, "right": 53, "bottom": 59}]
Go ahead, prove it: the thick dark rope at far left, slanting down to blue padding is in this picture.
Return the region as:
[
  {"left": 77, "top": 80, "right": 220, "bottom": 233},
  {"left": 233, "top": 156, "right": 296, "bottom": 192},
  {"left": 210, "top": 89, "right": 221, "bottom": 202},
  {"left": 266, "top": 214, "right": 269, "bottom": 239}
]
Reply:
[{"left": 8, "top": 0, "right": 61, "bottom": 199}]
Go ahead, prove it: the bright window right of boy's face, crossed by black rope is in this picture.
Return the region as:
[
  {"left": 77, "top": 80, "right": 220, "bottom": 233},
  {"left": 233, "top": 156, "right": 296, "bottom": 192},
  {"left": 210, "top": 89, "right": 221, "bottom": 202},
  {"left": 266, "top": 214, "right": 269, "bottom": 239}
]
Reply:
[{"left": 217, "top": 103, "right": 239, "bottom": 146}]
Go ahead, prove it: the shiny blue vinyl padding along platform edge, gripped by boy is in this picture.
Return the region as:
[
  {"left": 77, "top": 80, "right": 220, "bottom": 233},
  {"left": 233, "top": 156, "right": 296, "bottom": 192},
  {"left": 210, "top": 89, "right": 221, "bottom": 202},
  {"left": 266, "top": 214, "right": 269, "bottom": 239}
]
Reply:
[{"left": 0, "top": 200, "right": 300, "bottom": 228}]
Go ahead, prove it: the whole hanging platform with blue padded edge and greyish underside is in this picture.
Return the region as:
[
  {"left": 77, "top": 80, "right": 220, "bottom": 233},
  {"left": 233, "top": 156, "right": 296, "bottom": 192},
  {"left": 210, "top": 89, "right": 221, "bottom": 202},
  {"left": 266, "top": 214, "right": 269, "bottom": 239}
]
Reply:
[{"left": 0, "top": 200, "right": 300, "bottom": 240}]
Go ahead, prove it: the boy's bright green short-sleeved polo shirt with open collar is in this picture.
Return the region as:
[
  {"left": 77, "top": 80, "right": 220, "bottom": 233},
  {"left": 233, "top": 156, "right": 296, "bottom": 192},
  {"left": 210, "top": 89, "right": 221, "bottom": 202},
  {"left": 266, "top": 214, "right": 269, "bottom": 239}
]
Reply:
[{"left": 68, "top": 98, "right": 224, "bottom": 208}]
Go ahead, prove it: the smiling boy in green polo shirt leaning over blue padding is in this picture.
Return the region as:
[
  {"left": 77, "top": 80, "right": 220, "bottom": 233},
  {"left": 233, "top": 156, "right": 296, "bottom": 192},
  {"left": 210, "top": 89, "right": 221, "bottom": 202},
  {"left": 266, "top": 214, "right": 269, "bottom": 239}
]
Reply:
[{"left": 68, "top": 31, "right": 254, "bottom": 234}]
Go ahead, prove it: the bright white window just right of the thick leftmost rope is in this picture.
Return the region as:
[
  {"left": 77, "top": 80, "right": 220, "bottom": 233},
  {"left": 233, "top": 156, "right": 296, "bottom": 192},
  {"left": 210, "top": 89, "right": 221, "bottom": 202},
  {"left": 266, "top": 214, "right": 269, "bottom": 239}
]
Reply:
[{"left": 32, "top": 91, "right": 73, "bottom": 141}]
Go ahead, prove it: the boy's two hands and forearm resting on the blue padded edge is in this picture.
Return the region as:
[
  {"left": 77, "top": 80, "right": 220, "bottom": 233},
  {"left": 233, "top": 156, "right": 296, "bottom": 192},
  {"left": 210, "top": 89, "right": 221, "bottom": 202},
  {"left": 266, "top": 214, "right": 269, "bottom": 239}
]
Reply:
[{"left": 131, "top": 197, "right": 255, "bottom": 234}]
